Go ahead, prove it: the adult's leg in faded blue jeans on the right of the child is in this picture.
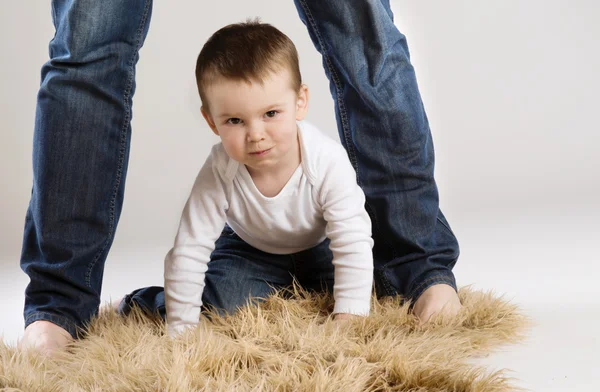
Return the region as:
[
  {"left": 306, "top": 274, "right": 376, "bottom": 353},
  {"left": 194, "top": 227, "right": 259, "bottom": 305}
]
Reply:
[{"left": 295, "top": 0, "right": 459, "bottom": 318}]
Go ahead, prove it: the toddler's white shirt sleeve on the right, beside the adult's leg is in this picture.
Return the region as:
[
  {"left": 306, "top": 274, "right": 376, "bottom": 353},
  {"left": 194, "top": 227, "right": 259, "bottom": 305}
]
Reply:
[{"left": 319, "top": 146, "right": 373, "bottom": 316}]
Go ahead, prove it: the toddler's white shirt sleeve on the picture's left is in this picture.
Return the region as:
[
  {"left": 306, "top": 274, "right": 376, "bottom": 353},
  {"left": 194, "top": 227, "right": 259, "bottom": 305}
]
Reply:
[{"left": 164, "top": 150, "right": 228, "bottom": 336}]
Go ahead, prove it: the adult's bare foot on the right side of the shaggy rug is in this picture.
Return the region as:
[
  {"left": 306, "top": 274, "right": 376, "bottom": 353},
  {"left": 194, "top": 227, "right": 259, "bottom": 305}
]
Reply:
[{"left": 413, "top": 284, "right": 462, "bottom": 325}]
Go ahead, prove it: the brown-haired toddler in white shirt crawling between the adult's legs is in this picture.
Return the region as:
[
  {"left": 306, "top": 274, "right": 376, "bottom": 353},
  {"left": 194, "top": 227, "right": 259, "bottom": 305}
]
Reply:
[{"left": 119, "top": 22, "right": 373, "bottom": 336}]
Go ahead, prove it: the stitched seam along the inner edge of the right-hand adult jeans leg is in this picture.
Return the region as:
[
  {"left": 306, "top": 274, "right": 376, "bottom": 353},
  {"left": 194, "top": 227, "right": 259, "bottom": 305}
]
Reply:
[{"left": 298, "top": 0, "right": 396, "bottom": 259}]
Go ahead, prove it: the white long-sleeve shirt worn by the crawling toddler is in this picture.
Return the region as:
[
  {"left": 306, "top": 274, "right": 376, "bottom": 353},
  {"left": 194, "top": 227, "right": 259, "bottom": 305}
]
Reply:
[{"left": 164, "top": 121, "right": 373, "bottom": 336}]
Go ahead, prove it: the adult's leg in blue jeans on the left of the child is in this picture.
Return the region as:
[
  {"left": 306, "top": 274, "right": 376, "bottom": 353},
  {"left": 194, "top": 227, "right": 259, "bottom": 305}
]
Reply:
[{"left": 21, "top": 0, "right": 152, "bottom": 349}]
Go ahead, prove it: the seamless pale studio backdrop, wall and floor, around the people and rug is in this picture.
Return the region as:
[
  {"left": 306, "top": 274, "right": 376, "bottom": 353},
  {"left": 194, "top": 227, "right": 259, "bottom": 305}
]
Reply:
[{"left": 0, "top": 0, "right": 600, "bottom": 391}]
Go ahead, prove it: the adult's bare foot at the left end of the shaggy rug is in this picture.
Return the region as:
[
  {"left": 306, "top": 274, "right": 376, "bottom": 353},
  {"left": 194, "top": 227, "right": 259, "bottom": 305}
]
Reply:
[{"left": 17, "top": 320, "right": 73, "bottom": 355}]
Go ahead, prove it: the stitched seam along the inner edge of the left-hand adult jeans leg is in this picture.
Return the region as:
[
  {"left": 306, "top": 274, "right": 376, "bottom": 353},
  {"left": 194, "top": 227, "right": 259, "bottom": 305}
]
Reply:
[{"left": 85, "top": 0, "right": 152, "bottom": 287}]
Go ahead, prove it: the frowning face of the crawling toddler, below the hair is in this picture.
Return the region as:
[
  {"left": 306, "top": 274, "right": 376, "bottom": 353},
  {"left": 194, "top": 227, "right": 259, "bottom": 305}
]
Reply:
[{"left": 202, "top": 69, "right": 308, "bottom": 172}]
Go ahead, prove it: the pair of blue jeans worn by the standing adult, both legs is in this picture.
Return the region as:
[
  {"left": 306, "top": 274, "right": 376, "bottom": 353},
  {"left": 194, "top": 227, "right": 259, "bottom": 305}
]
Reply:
[{"left": 21, "top": 0, "right": 459, "bottom": 337}]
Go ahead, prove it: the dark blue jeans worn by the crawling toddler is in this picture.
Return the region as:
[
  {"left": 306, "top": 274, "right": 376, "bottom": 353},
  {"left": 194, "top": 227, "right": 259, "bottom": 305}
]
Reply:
[{"left": 118, "top": 226, "right": 334, "bottom": 319}]
